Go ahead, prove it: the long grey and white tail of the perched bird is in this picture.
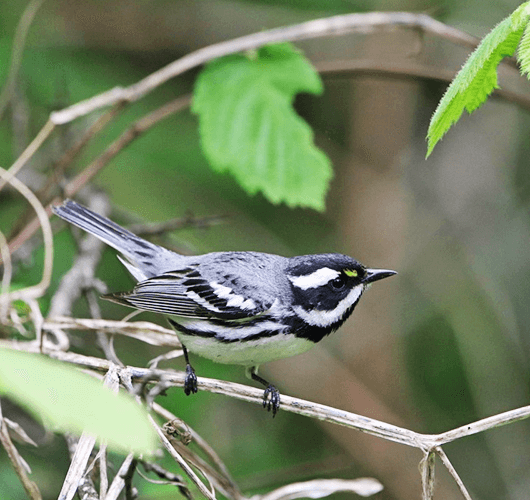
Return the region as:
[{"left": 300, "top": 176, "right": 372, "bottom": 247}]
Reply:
[{"left": 53, "top": 200, "right": 182, "bottom": 281}]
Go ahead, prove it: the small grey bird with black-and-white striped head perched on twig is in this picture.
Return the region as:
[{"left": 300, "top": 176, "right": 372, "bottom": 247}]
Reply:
[{"left": 53, "top": 200, "right": 396, "bottom": 415}]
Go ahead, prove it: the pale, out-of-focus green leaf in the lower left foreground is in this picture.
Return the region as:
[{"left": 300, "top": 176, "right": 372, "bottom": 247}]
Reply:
[{"left": 0, "top": 349, "right": 157, "bottom": 454}]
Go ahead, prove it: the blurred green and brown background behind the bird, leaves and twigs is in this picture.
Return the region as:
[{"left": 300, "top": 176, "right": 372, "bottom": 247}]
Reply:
[{"left": 0, "top": 0, "right": 530, "bottom": 500}]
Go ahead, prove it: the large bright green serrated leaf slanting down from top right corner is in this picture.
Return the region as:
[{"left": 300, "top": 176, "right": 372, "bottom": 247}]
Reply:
[{"left": 427, "top": 2, "right": 530, "bottom": 157}]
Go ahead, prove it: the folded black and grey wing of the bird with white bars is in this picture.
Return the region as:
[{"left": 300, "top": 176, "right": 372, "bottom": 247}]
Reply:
[{"left": 103, "top": 265, "right": 272, "bottom": 321}]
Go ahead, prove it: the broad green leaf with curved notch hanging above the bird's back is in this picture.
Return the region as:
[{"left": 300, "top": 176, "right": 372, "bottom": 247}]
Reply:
[{"left": 192, "top": 44, "right": 333, "bottom": 210}]
